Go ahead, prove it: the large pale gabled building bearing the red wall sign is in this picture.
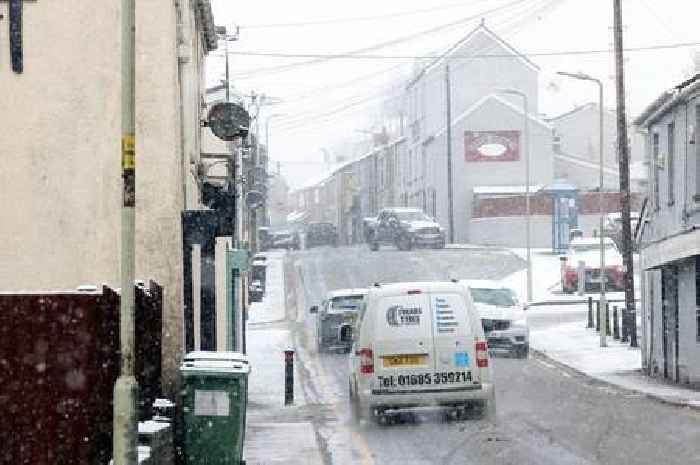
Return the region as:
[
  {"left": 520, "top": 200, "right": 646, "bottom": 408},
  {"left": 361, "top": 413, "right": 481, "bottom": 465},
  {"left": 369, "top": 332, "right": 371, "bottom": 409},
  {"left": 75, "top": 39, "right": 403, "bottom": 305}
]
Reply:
[{"left": 397, "top": 22, "right": 553, "bottom": 242}]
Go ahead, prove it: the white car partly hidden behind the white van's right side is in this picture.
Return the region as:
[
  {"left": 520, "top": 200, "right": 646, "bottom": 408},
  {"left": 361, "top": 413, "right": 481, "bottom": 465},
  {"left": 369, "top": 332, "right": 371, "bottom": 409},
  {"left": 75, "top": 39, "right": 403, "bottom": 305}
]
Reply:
[{"left": 460, "top": 279, "right": 530, "bottom": 358}]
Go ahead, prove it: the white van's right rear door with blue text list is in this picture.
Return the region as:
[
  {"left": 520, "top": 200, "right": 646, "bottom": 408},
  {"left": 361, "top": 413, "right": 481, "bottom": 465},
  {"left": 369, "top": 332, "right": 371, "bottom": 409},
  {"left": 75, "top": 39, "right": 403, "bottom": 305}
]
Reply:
[{"left": 429, "top": 293, "right": 480, "bottom": 388}]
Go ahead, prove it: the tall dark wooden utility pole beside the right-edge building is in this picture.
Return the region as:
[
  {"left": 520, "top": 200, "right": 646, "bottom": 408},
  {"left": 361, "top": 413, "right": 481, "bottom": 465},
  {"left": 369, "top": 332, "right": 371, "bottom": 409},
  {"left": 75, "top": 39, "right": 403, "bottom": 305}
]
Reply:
[{"left": 612, "top": 0, "right": 637, "bottom": 347}]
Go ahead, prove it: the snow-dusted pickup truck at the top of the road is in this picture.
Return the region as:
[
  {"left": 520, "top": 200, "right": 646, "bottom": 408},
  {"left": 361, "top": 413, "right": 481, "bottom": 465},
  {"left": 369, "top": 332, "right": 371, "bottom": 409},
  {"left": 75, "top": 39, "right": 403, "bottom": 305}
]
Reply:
[{"left": 369, "top": 208, "right": 445, "bottom": 251}]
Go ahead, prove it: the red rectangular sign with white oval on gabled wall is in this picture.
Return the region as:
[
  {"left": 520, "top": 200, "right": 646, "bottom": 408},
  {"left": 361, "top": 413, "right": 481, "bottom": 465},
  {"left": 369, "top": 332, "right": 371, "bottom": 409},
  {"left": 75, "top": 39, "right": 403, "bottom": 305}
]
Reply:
[{"left": 464, "top": 131, "right": 520, "bottom": 161}]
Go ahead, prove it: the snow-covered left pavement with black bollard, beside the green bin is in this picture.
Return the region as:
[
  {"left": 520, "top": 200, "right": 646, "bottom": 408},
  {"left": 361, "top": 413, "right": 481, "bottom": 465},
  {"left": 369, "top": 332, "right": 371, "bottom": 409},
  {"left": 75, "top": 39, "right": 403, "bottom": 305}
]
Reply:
[{"left": 244, "top": 251, "right": 324, "bottom": 465}]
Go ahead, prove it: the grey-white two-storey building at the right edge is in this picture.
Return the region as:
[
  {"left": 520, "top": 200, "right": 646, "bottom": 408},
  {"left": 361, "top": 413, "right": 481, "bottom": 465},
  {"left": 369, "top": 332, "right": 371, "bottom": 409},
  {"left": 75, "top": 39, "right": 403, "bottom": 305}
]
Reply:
[{"left": 635, "top": 74, "right": 700, "bottom": 386}]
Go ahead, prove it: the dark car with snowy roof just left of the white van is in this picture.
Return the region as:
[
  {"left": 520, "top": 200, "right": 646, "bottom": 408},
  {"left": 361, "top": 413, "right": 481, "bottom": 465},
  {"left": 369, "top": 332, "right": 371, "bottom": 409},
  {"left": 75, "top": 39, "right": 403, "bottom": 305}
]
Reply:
[{"left": 309, "top": 289, "right": 367, "bottom": 352}]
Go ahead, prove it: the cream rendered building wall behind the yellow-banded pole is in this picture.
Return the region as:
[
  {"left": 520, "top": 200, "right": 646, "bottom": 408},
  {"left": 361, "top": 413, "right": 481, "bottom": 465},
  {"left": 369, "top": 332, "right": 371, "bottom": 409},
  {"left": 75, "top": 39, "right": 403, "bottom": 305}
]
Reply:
[{"left": 0, "top": 0, "right": 217, "bottom": 389}]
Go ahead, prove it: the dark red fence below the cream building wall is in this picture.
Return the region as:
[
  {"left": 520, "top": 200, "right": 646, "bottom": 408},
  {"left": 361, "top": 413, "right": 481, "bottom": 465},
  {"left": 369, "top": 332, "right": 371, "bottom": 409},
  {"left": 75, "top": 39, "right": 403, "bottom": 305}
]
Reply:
[{"left": 0, "top": 282, "right": 162, "bottom": 465}]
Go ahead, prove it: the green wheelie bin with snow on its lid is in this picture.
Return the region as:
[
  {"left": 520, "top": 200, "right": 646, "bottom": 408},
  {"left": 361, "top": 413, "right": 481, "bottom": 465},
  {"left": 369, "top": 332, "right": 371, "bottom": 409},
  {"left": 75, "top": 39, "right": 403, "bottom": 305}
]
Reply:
[{"left": 180, "top": 351, "right": 250, "bottom": 465}]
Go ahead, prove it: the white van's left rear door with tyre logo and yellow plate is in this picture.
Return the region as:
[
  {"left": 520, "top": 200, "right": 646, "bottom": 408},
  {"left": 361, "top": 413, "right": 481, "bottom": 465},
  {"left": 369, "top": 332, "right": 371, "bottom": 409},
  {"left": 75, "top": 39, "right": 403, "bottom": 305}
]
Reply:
[{"left": 372, "top": 290, "right": 435, "bottom": 392}]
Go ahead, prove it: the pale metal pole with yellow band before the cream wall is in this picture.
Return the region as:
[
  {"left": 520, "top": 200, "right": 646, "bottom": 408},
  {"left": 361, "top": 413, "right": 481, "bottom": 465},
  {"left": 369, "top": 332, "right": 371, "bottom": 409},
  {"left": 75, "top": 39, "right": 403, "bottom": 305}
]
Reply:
[{"left": 112, "top": 0, "right": 138, "bottom": 465}]
